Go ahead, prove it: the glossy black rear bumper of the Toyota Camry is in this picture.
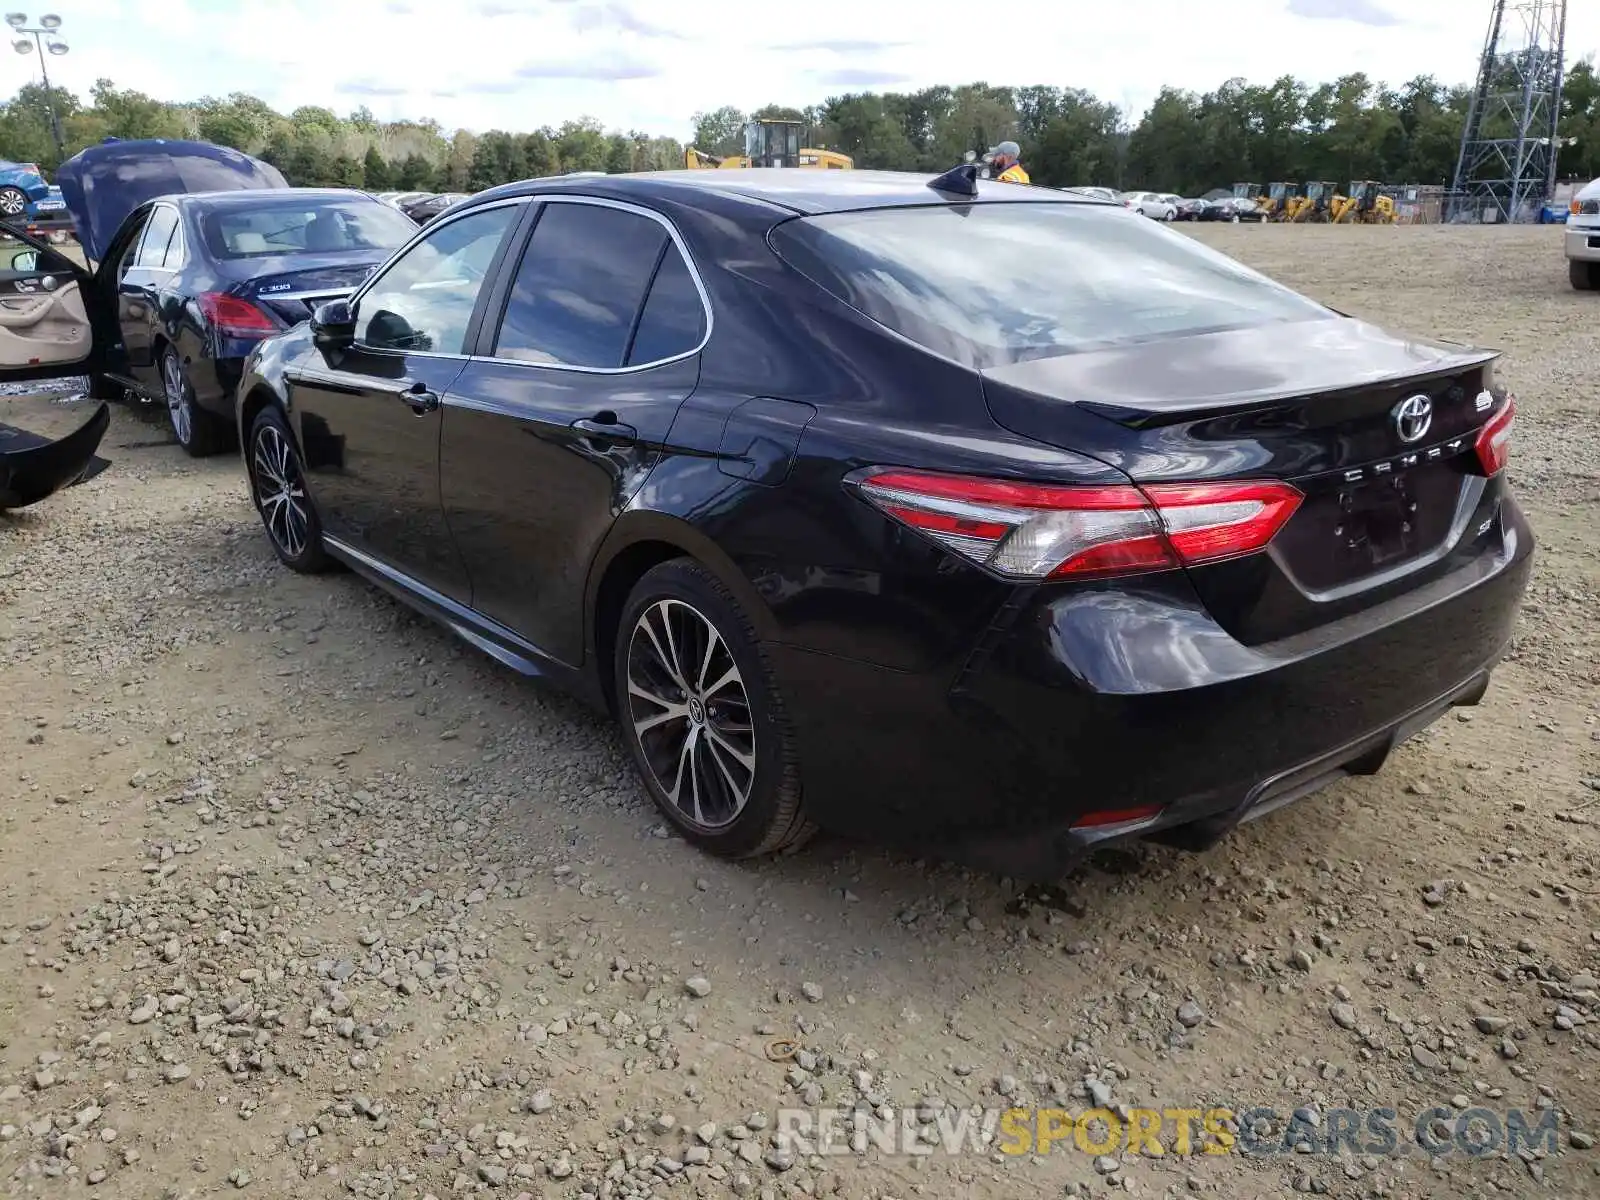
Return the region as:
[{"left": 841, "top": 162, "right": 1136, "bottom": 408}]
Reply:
[{"left": 768, "top": 499, "right": 1533, "bottom": 880}]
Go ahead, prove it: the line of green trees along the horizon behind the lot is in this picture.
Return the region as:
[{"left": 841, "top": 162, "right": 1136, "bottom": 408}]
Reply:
[{"left": 0, "top": 61, "right": 1600, "bottom": 195}]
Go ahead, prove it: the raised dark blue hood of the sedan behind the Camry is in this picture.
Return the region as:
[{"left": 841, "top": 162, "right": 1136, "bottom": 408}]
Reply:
[{"left": 56, "top": 138, "right": 288, "bottom": 262}]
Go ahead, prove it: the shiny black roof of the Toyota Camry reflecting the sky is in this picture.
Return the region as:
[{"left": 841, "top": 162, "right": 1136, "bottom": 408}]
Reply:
[{"left": 462, "top": 166, "right": 1104, "bottom": 216}]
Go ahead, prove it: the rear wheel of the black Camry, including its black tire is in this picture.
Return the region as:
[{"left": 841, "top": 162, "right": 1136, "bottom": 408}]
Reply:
[{"left": 613, "top": 558, "right": 816, "bottom": 859}]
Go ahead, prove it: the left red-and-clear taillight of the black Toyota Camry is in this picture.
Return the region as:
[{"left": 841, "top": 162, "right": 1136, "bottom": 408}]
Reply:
[{"left": 856, "top": 469, "right": 1301, "bottom": 579}]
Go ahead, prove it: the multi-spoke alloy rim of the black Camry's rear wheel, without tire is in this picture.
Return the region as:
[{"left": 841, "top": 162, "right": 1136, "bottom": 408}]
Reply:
[{"left": 627, "top": 600, "right": 755, "bottom": 830}]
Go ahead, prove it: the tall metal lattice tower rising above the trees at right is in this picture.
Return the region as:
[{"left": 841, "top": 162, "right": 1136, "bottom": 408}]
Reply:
[{"left": 1446, "top": 0, "right": 1566, "bottom": 221}]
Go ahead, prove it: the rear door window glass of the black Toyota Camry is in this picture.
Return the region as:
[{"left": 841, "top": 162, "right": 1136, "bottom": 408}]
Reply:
[{"left": 494, "top": 203, "right": 668, "bottom": 368}]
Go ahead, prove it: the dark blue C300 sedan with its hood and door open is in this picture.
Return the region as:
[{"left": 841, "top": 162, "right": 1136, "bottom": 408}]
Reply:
[{"left": 0, "top": 141, "right": 416, "bottom": 456}]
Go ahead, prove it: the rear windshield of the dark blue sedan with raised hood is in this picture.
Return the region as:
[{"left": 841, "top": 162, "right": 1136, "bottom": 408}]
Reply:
[{"left": 200, "top": 197, "right": 416, "bottom": 259}]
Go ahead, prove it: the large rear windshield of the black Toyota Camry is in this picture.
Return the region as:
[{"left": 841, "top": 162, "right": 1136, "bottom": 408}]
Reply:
[{"left": 771, "top": 203, "right": 1328, "bottom": 368}]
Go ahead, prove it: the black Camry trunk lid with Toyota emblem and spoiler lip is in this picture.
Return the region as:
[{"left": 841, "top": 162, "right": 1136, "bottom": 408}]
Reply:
[{"left": 984, "top": 317, "right": 1499, "bottom": 643}]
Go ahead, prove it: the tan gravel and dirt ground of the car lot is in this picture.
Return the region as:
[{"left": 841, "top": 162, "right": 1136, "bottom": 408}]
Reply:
[{"left": 0, "top": 227, "right": 1600, "bottom": 1200}]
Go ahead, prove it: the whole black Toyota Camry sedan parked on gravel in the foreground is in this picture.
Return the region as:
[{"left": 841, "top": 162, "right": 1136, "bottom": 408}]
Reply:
[{"left": 222, "top": 170, "right": 1533, "bottom": 878}]
